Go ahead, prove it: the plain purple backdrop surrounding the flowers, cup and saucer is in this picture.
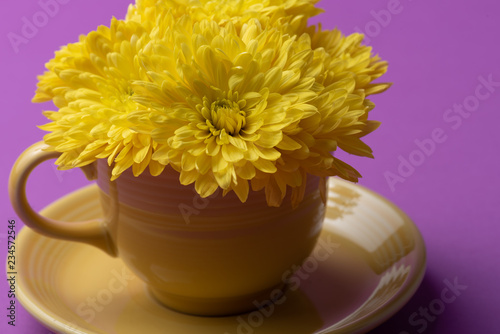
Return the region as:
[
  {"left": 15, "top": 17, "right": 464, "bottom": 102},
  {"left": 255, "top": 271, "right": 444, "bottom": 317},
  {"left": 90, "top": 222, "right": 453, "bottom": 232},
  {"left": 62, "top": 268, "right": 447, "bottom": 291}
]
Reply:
[{"left": 0, "top": 0, "right": 500, "bottom": 334}]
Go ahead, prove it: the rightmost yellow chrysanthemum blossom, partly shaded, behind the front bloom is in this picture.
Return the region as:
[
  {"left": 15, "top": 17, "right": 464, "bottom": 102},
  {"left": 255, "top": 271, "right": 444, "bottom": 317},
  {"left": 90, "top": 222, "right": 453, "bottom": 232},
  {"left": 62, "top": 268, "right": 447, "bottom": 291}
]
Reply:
[{"left": 252, "top": 28, "right": 390, "bottom": 206}]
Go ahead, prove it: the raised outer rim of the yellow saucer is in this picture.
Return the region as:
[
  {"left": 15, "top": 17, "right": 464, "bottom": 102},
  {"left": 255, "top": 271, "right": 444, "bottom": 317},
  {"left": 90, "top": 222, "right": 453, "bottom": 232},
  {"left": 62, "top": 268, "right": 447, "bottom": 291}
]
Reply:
[{"left": 16, "top": 183, "right": 427, "bottom": 334}]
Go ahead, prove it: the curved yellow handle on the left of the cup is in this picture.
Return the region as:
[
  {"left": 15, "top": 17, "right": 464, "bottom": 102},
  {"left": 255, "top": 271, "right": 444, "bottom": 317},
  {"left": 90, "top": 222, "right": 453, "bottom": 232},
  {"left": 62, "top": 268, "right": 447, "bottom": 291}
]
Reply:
[{"left": 9, "top": 142, "right": 116, "bottom": 256}]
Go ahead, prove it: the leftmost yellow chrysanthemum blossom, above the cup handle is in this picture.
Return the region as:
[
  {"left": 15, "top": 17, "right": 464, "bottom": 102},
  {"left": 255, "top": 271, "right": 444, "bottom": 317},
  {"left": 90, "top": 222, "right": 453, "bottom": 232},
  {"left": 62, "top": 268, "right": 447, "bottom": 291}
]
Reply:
[{"left": 33, "top": 19, "right": 165, "bottom": 179}]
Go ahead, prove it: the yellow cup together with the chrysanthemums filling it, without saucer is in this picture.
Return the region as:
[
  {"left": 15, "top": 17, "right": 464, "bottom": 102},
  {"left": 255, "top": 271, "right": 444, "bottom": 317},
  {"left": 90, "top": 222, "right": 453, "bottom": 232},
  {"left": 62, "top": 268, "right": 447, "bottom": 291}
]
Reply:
[{"left": 9, "top": 0, "right": 390, "bottom": 316}]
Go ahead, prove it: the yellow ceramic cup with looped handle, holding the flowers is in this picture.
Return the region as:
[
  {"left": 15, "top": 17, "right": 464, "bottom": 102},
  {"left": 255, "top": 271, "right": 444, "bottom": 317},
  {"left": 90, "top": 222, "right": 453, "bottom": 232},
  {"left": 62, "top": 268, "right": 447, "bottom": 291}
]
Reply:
[{"left": 9, "top": 143, "right": 326, "bottom": 315}]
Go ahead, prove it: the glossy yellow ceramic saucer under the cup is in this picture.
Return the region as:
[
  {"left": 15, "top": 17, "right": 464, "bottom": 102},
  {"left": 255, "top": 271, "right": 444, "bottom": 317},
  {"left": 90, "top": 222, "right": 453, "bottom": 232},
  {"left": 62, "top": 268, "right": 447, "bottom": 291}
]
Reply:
[{"left": 16, "top": 179, "right": 425, "bottom": 334}]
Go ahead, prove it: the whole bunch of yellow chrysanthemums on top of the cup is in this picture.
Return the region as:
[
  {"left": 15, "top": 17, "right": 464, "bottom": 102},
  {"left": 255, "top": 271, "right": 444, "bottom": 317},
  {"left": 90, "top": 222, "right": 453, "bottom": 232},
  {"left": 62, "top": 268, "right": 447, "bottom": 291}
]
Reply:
[{"left": 33, "top": 0, "right": 390, "bottom": 206}]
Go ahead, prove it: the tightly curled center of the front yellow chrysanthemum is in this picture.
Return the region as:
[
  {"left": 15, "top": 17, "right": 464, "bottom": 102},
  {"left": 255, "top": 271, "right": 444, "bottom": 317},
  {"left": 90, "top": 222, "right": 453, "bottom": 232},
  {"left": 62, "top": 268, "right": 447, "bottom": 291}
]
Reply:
[{"left": 210, "top": 99, "right": 246, "bottom": 136}]
